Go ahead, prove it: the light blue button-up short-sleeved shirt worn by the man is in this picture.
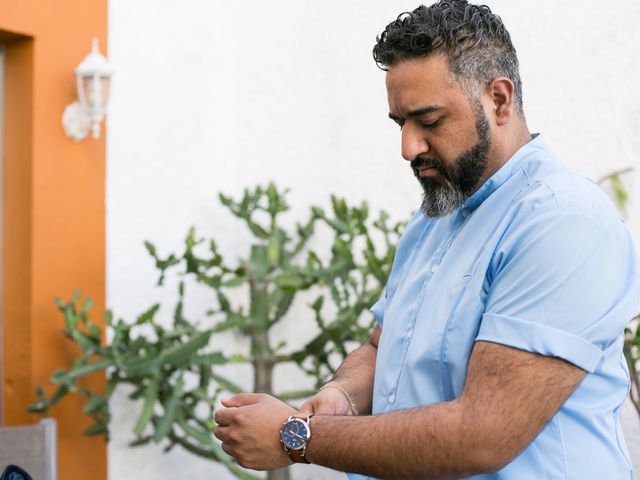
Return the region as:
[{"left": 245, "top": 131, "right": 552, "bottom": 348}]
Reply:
[{"left": 350, "top": 136, "right": 640, "bottom": 480}]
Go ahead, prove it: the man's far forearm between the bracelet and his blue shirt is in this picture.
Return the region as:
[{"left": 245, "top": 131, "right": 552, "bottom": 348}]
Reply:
[{"left": 329, "top": 328, "right": 380, "bottom": 414}]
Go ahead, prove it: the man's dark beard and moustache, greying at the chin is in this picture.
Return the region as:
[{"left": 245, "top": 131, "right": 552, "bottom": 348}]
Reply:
[{"left": 411, "top": 105, "right": 491, "bottom": 217}]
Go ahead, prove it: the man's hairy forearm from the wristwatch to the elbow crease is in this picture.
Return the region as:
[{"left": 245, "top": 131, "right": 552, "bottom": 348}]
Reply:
[{"left": 307, "top": 401, "right": 484, "bottom": 479}]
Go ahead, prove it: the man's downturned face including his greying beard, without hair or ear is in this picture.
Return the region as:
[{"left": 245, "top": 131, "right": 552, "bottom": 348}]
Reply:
[{"left": 387, "top": 55, "right": 491, "bottom": 217}]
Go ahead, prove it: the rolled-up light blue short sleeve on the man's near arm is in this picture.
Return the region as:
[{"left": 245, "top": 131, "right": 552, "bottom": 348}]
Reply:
[{"left": 476, "top": 209, "right": 639, "bottom": 372}]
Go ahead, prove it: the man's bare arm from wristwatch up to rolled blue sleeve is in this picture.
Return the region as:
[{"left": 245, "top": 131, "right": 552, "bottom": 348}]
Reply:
[{"left": 307, "top": 342, "right": 586, "bottom": 479}]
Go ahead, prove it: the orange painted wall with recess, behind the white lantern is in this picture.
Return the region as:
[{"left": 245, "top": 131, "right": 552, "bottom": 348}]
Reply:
[{"left": 0, "top": 0, "right": 107, "bottom": 480}]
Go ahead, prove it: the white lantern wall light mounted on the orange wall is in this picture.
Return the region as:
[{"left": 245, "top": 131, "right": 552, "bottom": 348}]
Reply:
[{"left": 62, "top": 38, "right": 113, "bottom": 142}]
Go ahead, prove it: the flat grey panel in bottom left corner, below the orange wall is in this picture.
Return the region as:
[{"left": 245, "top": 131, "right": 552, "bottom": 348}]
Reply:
[{"left": 0, "top": 418, "right": 58, "bottom": 480}]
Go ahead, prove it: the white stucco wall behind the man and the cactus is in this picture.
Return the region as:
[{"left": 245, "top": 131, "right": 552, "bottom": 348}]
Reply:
[{"left": 107, "top": 0, "right": 640, "bottom": 480}]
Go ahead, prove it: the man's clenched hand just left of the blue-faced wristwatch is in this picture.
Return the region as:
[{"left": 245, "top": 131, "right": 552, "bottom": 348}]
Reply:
[{"left": 213, "top": 393, "right": 296, "bottom": 470}]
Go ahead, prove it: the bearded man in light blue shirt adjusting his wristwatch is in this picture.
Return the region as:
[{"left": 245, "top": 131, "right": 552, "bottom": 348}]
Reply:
[{"left": 215, "top": 0, "right": 640, "bottom": 480}]
